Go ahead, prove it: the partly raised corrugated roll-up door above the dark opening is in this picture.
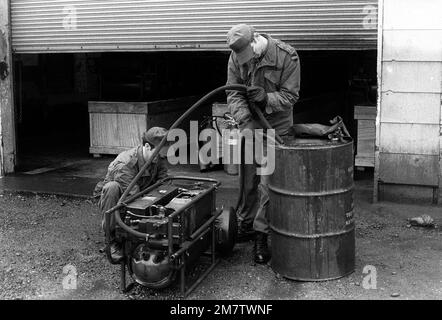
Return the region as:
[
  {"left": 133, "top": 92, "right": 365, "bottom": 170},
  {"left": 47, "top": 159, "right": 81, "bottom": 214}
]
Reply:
[{"left": 11, "top": 0, "right": 377, "bottom": 53}]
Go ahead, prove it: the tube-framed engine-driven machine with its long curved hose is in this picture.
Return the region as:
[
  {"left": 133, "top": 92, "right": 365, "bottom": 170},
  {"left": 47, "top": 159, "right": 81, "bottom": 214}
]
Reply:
[{"left": 105, "top": 85, "right": 252, "bottom": 297}]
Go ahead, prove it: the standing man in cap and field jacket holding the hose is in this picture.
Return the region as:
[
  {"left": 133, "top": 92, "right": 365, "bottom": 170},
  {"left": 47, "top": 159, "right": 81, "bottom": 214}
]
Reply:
[{"left": 227, "top": 24, "right": 300, "bottom": 263}]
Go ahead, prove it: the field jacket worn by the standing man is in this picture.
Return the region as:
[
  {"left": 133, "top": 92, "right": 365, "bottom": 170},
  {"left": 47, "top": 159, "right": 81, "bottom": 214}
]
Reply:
[{"left": 227, "top": 34, "right": 301, "bottom": 135}]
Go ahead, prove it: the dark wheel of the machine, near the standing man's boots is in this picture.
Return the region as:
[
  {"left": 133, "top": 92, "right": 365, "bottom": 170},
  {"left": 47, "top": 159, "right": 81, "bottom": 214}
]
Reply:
[{"left": 215, "top": 207, "right": 238, "bottom": 255}]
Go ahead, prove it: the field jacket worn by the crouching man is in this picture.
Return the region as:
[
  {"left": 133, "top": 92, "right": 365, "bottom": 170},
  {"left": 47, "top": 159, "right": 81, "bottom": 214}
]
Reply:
[{"left": 93, "top": 146, "right": 167, "bottom": 197}]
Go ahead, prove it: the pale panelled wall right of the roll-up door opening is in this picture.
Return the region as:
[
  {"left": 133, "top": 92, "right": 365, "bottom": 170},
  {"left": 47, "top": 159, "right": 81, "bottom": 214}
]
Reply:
[{"left": 374, "top": 0, "right": 442, "bottom": 202}]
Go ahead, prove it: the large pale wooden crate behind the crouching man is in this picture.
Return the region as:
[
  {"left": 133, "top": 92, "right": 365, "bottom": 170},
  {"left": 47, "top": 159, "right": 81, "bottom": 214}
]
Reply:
[{"left": 88, "top": 97, "right": 197, "bottom": 156}]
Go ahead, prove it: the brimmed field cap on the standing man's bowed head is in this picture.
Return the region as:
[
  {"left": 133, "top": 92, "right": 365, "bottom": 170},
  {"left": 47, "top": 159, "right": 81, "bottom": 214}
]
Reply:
[{"left": 227, "top": 23, "right": 255, "bottom": 64}]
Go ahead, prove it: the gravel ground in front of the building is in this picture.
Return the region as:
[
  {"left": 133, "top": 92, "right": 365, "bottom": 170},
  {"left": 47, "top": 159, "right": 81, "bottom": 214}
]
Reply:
[{"left": 0, "top": 188, "right": 442, "bottom": 300}]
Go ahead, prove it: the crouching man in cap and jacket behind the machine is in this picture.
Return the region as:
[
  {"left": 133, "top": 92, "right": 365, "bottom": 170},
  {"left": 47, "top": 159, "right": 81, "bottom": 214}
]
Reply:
[{"left": 94, "top": 127, "right": 167, "bottom": 260}]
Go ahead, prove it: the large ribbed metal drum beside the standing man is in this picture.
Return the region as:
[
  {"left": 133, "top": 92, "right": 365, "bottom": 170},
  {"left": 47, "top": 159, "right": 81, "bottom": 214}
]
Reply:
[{"left": 268, "top": 137, "right": 355, "bottom": 281}]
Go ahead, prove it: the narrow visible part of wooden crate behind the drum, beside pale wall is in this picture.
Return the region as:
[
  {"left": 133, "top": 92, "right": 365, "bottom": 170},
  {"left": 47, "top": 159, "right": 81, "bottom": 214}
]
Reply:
[{"left": 354, "top": 106, "right": 376, "bottom": 167}]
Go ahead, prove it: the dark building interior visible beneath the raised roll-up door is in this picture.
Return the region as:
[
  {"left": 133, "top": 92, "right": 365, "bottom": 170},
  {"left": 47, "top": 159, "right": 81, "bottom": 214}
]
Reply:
[{"left": 10, "top": 50, "right": 376, "bottom": 184}]
